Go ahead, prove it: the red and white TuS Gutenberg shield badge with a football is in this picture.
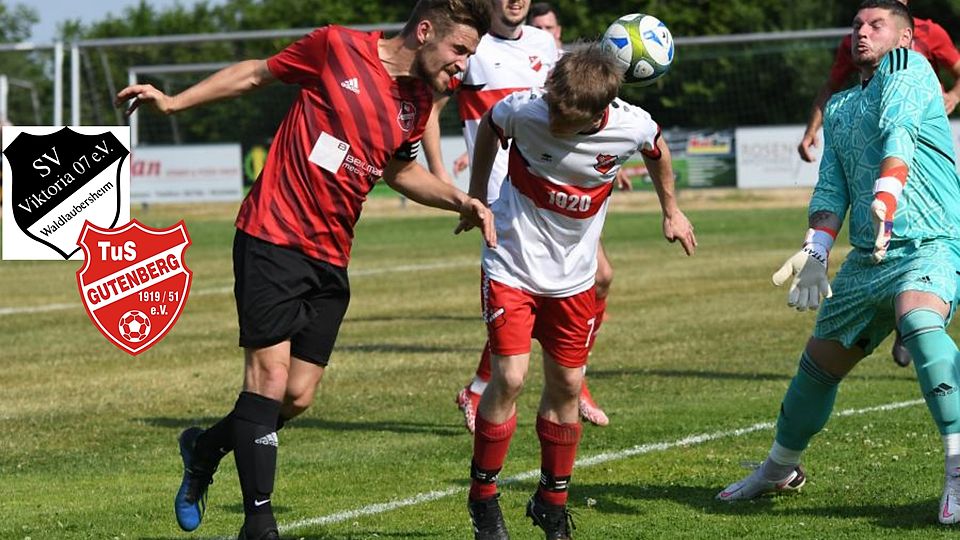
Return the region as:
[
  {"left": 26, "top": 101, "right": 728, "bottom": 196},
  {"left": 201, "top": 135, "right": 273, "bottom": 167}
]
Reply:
[{"left": 77, "top": 220, "right": 193, "bottom": 355}]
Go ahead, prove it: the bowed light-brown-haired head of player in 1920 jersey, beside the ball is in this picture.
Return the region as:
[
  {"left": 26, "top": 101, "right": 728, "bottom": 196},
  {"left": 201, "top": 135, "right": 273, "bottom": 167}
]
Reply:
[{"left": 544, "top": 43, "right": 623, "bottom": 137}]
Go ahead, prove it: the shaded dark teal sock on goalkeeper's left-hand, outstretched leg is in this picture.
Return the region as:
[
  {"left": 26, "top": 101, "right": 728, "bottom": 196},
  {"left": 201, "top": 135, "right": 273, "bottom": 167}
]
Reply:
[{"left": 776, "top": 351, "right": 840, "bottom": 451}]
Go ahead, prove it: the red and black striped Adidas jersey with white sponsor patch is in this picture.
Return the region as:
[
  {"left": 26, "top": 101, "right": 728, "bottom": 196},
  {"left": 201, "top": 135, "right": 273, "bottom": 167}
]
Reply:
[{"left": 236, "top": 26, "right": 433, "bottom": 267}]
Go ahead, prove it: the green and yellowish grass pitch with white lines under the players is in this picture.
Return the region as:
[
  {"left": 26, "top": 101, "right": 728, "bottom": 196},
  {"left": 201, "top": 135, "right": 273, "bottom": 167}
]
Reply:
[{"left": 0, "top": 195, "right": 957, "bottom": 540}]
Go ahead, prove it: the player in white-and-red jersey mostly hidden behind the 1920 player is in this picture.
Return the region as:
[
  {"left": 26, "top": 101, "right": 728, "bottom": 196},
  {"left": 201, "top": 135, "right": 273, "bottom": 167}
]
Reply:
[{"left": 423, "top": 0, "right": 613, "bottom": 433}]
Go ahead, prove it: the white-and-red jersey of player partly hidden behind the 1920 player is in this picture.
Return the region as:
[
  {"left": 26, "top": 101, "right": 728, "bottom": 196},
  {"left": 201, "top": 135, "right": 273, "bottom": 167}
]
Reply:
[{"left": 450, "top": 25, "right": 558, "bottom": 202}]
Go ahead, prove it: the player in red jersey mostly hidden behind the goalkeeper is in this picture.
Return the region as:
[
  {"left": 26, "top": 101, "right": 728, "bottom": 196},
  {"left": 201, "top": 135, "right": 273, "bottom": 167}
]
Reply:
[{"left": 797, "top": 0, "right": 960, "bottom": 367}]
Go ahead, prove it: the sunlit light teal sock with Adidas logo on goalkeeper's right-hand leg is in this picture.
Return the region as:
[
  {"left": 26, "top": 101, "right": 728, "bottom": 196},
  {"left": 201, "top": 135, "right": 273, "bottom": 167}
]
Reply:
[{"left": 899, "top": 308, "right": 960, "bottom": 435}]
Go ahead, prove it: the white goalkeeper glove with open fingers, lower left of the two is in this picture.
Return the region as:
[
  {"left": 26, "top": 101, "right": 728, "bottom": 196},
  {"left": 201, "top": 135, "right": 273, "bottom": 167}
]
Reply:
[{"left": 773, "top": 229, "right": 833, "bottom": 311}]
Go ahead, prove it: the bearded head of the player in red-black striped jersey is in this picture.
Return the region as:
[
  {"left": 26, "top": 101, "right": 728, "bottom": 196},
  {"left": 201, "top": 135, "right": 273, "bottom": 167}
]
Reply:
[{"left": 400, "top": 0, "right": 490, "bottom": 92}]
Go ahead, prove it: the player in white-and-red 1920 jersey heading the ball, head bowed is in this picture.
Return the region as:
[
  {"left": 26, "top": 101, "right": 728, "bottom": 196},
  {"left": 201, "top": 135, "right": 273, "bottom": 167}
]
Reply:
[{"left": 468, "top": 44, "right": 696, "bottom": 539}]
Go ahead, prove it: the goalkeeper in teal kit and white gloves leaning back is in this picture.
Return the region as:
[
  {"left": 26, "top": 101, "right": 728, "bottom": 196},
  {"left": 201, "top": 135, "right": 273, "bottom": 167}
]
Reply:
[{"left": 717, "top": 0, "right": 960, "bottom": 523}]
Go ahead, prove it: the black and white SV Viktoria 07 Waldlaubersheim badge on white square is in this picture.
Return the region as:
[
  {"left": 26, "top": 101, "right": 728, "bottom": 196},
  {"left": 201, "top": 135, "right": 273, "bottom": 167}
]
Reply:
[{"left": 0, "top": 126, "right": 130, "bottom": 260}]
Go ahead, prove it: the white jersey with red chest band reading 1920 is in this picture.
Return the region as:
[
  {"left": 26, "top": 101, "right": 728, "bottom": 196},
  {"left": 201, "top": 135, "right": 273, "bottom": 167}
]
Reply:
[{"left": 483, "top": 90, "right": 660, "bottom": 298}]
